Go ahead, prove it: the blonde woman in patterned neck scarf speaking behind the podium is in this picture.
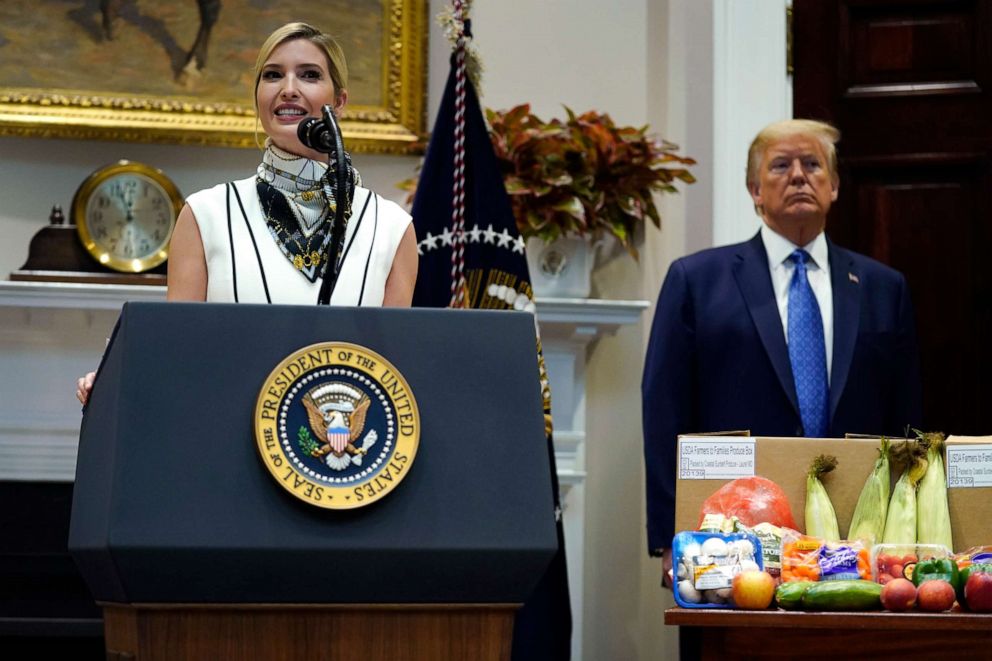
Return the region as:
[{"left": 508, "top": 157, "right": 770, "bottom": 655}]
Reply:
[{"left": 76, "top": 23, "right": 417, "bottom": 404}]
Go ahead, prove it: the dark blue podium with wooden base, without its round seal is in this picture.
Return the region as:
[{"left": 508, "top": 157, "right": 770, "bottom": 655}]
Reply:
[{"left": 69, "top": 303, "right": 557, "bottom": 659}]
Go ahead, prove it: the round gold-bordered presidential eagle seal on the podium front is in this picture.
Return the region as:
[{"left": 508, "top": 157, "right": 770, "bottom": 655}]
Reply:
[{"left": 255, "top": 342, "right": 420, "bottom": 509}]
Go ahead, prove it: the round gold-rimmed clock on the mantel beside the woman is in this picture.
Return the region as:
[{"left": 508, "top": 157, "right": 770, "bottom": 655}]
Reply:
[{"left": 73, "top": 163, "right": 181, "bottom": 273}]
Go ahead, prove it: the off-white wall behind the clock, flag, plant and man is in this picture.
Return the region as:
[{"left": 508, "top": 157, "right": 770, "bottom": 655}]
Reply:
[{"left": 0, "top": 0, "right": 789, "bottom": 659}]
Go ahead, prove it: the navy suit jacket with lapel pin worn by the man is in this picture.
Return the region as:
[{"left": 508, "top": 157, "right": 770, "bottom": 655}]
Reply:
[{"left": 641, "top": 232, "right": 921, "bottom": 551}]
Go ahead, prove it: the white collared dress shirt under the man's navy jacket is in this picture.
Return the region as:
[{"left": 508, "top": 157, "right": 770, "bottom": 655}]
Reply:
[{"left": 761, "top": 224, "right": 834, "bottom": 384}]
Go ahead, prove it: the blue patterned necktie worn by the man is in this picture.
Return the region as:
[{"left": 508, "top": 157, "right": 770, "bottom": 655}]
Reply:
[{"left": 789, "top": 250, "right": 829, "bottom": 437}]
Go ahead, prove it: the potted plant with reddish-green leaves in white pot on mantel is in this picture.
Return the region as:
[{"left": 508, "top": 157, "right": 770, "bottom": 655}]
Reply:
[{"left": 486, "top": 104, "right": 695, "bottom": 296}]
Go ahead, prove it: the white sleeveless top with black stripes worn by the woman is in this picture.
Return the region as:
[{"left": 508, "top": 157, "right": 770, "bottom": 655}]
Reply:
[{"left": 186, "top": 177, "right": 411, "bottom": 306}]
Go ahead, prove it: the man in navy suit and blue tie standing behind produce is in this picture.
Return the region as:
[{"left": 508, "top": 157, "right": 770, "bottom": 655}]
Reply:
[{"left": 641, "top": 120, "right": 921, "bottom": 584}]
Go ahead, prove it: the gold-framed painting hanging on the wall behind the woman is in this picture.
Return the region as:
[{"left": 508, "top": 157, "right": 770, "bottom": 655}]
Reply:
[{"left": 0, "top": 0, "right": 428, "bottom": 153}]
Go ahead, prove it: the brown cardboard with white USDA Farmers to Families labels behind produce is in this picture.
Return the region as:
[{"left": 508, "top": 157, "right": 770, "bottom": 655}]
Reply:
[{"left": 675, "top": 435, "right": 992, "bottom": 551}]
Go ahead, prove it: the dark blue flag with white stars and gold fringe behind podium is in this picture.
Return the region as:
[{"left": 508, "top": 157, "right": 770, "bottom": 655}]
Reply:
[{"left": 412, "top": 57, "right": 572, "bottom": 661}]
